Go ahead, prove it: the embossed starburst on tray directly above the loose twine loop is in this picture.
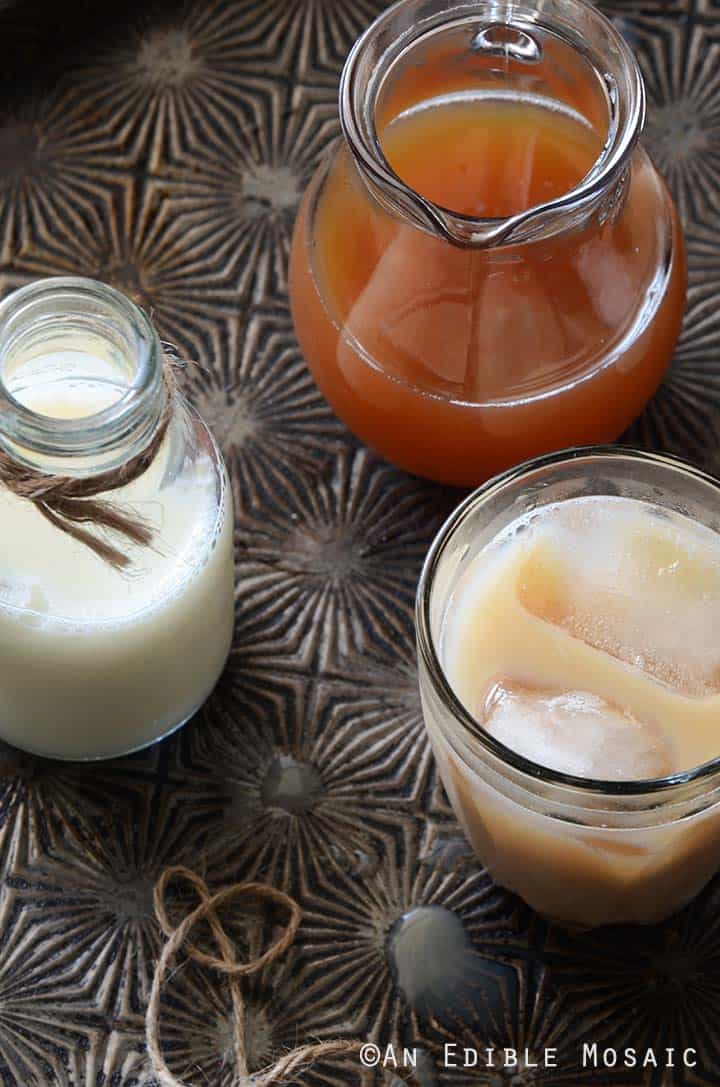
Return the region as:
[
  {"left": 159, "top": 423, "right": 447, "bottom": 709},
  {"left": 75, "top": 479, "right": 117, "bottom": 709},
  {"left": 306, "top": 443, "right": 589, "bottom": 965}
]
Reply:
[{"left": 165, "top": 658, "right": 417, "bottom": 897}]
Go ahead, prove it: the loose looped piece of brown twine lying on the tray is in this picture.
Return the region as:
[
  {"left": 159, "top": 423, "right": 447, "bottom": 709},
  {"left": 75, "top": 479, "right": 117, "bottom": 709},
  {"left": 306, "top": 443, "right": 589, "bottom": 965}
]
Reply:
[{"left": 146, "top": 865, "right": 417, "bottom": 1087}]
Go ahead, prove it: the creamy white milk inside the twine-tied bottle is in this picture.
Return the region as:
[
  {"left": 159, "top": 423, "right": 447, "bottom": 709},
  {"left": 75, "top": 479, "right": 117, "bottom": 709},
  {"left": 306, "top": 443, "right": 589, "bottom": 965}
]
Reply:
[{"left": 0, "top": 360, "right": 233, "bottom": 759}]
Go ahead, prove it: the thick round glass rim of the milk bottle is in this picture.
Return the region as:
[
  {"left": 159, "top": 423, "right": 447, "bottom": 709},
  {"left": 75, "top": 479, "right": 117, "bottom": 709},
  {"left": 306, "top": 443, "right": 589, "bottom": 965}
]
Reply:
[{"left": 0, "top": 276, "right": 162, "bottom": 458}]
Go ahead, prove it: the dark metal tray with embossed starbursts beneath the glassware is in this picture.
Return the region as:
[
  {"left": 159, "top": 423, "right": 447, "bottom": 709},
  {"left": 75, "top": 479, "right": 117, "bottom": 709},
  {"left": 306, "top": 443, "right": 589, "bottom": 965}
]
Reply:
[{"left": 0, "top": 0, "right": 720, "bottom": 1087}]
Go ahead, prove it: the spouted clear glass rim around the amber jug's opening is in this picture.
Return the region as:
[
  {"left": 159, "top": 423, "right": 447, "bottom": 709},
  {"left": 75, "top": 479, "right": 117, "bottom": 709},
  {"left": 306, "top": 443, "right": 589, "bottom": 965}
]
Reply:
[{"left": 339, "top": 0, "right": 645, "bottom": 248}]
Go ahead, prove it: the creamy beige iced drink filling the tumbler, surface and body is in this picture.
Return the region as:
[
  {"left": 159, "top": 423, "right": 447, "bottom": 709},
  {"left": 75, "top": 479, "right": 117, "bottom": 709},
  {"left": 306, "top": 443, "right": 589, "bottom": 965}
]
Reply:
[{"left": 429, "top": 498, "right": 720, "bottom": 925}]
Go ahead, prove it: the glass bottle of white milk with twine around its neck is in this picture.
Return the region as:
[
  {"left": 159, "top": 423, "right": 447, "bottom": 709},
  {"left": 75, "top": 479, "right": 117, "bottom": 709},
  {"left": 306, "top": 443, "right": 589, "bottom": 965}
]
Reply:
[{"left": 0, "top": 278, "right": 234, "bottom": 760}]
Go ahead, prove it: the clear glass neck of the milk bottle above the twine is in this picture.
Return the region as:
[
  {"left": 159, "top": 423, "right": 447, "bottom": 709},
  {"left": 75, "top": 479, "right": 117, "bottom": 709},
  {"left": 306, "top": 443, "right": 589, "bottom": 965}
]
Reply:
[{"left": 0, "top": 277, "right": 166, "bottom": 476}]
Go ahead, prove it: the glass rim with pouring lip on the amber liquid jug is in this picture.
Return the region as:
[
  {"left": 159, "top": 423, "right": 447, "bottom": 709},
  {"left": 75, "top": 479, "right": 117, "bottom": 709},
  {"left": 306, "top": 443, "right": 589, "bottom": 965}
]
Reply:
[{"left": 338, "top": 0, "right": 646, "bottom": 246}]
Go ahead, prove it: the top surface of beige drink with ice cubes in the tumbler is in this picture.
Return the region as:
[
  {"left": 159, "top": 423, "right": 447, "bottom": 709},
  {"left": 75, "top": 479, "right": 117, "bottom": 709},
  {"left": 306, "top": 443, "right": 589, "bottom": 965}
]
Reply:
[{"left": 444, "top": 498, "right": 720, "bottom": 780}]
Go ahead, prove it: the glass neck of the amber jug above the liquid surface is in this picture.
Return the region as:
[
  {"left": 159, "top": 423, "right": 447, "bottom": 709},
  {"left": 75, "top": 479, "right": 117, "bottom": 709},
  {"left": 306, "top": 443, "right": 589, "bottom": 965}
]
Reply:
[{"left": 339, "top": 0, "right": 645, "bottom": 248}]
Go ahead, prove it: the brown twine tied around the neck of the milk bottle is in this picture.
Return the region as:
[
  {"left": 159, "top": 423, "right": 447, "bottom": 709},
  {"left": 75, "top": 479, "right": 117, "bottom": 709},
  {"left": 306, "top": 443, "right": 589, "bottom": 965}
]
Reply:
[{"left": 0, "top": 367, "right": 175, "bottom": 570}]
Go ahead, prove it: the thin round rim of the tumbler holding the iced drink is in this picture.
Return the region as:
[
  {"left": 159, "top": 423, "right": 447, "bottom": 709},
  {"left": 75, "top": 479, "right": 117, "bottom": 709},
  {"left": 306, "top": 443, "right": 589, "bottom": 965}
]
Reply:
[{"left": 415, "top": 445, "right": 720, "bottom": 798}]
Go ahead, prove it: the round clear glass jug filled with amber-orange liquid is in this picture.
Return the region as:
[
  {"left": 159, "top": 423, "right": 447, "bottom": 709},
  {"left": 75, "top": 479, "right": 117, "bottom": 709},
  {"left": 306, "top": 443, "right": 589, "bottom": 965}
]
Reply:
[{"left": 290, "top": 0, "right": 685, "bottom": 485}]
